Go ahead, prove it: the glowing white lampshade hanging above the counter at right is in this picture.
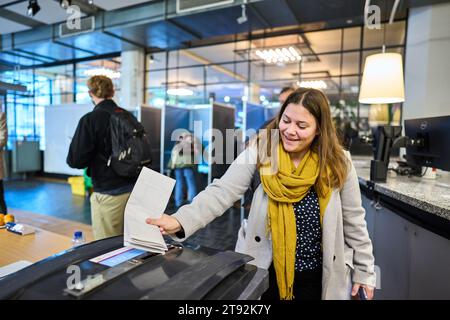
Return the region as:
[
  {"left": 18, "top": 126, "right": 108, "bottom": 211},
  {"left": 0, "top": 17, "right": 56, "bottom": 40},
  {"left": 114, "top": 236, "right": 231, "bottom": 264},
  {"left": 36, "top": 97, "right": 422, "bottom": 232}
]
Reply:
[{"left": 359, "top": 53, "right": 405, "bottom": 104}]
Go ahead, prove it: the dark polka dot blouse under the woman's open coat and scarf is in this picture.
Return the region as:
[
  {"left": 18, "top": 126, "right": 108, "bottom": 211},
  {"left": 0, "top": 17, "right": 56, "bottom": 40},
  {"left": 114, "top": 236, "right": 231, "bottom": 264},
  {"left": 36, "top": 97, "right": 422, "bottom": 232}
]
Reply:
[{"left": 294, "top": 188, "right": 322, "bottom": 271}]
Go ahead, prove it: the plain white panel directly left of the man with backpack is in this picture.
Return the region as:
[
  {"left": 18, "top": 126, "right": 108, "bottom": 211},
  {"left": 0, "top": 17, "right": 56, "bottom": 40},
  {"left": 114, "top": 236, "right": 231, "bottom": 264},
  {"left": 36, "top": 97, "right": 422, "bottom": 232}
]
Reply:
[{"left": 44, "top": 103, "right": 93, "bottom": 175}]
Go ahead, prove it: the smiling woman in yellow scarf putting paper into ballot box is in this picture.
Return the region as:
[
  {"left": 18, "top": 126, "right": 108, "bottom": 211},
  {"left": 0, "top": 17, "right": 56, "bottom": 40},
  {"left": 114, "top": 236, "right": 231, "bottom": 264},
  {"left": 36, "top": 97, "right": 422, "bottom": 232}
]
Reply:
[{"left": 147, "top": 88, "right": 375, "bottom": 299}]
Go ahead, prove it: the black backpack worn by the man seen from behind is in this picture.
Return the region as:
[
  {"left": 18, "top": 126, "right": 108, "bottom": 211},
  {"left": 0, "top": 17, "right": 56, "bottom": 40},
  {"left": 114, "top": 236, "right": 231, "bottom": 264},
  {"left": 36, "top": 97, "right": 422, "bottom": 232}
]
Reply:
[{"left": 107, "top": 107, "right": 152, "bottom": 178}]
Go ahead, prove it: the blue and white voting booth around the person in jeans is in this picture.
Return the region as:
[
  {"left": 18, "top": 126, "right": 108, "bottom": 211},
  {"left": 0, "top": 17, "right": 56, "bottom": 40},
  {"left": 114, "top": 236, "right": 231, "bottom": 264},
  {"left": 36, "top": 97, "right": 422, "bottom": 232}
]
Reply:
[{"left": 161, "top": 102, "right": 235, "bottom": 184}]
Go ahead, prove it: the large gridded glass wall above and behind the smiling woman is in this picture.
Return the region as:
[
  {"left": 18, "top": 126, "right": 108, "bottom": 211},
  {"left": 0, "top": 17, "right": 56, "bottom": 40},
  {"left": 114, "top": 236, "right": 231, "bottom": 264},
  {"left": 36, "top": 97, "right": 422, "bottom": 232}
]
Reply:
[{"left": 146, "top": 21, "right": 406, "bottom": 154}]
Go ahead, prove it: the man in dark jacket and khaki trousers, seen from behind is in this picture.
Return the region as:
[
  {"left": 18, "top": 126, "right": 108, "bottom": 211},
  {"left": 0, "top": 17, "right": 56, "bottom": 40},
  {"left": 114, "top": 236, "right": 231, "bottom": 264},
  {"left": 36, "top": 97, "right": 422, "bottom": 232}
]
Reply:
[{"left": 67, "top": 76, "right": 136, "bottom": 240}]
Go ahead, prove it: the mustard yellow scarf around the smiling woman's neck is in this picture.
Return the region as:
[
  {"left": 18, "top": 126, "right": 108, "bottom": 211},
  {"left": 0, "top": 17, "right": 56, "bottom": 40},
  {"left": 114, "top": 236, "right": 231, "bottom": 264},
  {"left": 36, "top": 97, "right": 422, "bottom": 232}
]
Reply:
[{"left": 260, "top": 143, "right": 331, "bottom": 300}]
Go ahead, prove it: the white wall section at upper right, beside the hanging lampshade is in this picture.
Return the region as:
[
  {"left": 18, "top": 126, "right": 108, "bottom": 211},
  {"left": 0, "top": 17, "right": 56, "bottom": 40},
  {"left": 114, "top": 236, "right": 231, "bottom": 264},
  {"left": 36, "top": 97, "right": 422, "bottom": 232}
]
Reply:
[{"left": 403, "top": 3, "right": 450, "bottom": 119}]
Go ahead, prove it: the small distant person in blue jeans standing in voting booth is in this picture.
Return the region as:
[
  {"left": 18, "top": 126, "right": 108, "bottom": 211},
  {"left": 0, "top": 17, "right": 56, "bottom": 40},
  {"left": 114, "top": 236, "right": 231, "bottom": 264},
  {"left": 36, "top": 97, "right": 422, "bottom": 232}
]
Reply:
[{"left": 168, "top": 132, "right": 200, "bottom": 208}]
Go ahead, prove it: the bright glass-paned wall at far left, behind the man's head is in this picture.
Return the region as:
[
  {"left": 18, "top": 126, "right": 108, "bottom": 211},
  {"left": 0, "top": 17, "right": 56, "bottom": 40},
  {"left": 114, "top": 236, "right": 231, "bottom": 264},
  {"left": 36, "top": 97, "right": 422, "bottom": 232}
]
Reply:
[{"left": 0, "top": 57, "right": 120, "bottom": 150}]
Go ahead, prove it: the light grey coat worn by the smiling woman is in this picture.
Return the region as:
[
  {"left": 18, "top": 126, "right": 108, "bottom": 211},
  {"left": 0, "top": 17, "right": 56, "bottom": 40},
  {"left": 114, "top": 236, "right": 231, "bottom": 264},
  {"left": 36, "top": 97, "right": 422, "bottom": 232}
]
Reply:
[{"left": 173, "top": 147, "right": 376, "bottom": 299}]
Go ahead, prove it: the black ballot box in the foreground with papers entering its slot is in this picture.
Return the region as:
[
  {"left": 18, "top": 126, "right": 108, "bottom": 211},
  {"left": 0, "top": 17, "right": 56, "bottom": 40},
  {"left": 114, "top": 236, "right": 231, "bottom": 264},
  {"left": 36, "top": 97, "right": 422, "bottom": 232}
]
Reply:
[{"left": 0, "top": 236, "right": 269, "bottom": 300}]
